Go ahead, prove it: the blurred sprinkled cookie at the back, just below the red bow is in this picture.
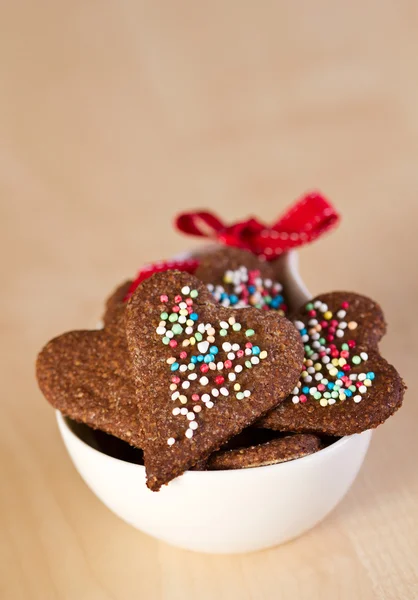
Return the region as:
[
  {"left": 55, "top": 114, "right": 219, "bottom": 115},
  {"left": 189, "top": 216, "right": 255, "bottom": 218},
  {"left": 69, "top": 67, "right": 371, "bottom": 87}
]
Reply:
[{"left": 195, "top": 247, "right": 287, "bottom": 316}]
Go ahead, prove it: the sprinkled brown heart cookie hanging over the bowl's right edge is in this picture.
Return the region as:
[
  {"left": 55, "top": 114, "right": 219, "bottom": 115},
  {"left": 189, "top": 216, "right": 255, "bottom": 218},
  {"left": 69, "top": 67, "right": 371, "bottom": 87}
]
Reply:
[{"left": 260, "top": 292, "right": 405, "bottom": 436}]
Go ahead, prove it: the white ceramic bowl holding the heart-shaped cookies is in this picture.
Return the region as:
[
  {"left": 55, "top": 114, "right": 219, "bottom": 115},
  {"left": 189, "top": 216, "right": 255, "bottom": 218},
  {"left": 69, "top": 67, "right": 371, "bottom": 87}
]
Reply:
[{"left": 57, "top": 253, "right": 371, "bottom": 553}]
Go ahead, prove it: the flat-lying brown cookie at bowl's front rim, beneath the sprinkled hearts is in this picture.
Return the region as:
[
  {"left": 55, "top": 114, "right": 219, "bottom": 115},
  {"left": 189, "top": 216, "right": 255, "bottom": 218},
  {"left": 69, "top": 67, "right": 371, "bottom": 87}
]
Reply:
[{"left": 206, "top": 433, "right": 322, "bottom": 471}]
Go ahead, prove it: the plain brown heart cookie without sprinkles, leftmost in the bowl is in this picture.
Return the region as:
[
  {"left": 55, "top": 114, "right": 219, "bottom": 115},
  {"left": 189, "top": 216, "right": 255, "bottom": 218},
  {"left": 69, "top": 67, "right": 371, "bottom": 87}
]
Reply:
[{"left": 36, "top": 317, "right": 142, "bottom": 448}]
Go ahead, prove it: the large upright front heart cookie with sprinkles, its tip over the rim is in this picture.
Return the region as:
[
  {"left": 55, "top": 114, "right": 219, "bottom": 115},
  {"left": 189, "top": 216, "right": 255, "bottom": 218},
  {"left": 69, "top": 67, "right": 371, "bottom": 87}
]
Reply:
[{"left": 125, "top": 271, "right": 303, "bottom": 490}]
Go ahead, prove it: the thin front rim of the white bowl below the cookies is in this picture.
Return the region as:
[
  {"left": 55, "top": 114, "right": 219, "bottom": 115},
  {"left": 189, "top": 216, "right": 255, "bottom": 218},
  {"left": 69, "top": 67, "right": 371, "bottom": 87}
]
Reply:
[{"left": 55, "top": 410, "right": 372, "bottom": 481}]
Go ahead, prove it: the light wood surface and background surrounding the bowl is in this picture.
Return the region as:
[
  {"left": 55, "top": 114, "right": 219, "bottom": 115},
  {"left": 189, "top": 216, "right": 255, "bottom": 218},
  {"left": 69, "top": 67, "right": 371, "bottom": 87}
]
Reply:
[{"left": 0, "top": 0, "right": 418, "bottom": 600}]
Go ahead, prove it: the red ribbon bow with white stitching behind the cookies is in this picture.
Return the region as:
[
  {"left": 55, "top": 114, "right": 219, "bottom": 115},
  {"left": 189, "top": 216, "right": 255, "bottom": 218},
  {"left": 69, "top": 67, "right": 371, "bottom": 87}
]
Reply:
[{"left": 175, "top": 192, "right": 340, "bottom": 260}]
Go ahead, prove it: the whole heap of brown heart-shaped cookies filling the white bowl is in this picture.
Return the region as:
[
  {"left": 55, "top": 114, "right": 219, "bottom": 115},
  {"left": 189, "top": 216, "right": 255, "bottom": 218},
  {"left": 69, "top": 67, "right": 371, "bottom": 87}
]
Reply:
[{"left": 37, "top": 247, "right": 404, "bottom": 491}]
